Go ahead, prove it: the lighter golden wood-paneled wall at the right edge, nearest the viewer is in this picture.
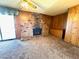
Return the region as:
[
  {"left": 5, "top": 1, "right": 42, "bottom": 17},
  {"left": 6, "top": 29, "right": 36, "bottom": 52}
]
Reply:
[{"left": 65, "top": 5, "right": 79, "bottom": 46}]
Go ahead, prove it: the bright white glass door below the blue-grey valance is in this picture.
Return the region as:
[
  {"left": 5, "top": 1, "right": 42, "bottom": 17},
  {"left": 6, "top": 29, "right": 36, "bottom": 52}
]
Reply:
[{"left": 0, "top": 15, "right": 16, "bottom": 40}]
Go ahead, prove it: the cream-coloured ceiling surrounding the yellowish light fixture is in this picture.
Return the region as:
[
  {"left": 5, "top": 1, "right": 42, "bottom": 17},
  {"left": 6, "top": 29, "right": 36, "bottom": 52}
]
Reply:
[{"left": 0, "top": 0, "right": 79, "bottom": 16}]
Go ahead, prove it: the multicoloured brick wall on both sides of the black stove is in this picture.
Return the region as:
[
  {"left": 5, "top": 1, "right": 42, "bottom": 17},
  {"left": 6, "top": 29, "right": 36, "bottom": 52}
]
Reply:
[{"left": 16, "top": 11, "right": 51, "bottom": 38}]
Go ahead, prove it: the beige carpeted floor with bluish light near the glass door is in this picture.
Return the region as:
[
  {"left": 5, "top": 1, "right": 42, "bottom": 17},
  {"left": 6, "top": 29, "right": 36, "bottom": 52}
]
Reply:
[{"left": 0, "top": 36, "right": 79, "bottom": 59}]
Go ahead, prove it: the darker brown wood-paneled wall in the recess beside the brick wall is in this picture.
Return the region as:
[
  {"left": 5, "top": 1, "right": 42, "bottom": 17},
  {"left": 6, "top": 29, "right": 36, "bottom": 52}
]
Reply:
[{"left": 50, "top": 13, "right": 67, "bottom": 38}]
